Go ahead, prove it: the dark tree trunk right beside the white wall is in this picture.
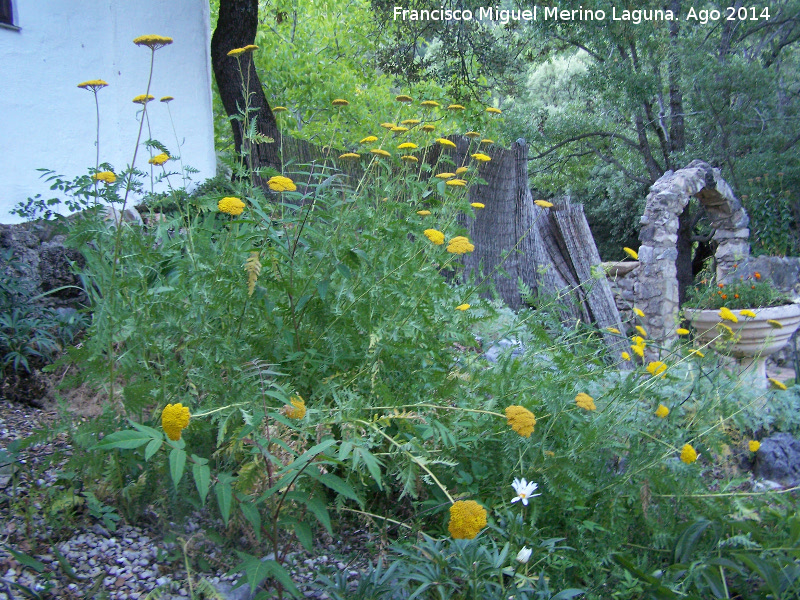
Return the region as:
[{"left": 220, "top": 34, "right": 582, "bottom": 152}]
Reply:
[{"left": 211, "top": 0, "right": 281, "bottom": 187}]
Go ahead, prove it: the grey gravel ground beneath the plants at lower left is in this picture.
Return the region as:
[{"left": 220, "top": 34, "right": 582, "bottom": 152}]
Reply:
[{"left": 0, "top": 400, "right": 372, "bottom": 600}]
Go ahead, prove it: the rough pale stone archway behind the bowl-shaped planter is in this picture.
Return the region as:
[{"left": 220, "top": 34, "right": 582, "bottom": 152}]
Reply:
[{"left": 634, "top": 160, "right": 750, "bottom": 344}]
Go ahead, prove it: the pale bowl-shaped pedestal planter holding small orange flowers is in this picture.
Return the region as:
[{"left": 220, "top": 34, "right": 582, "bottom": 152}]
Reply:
[{"left": 683, "top": 304, "right": 800, "bottom": 387}]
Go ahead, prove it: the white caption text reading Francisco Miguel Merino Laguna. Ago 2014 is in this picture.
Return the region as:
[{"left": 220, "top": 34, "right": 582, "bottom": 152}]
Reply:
[{"left": 394, "top": 5, "right": 769, "bottom": 25}]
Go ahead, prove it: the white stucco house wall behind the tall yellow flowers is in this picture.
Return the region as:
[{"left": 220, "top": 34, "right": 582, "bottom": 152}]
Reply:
[{"left": 0, "top": 0, "right": 216, "bottom": 223}]
